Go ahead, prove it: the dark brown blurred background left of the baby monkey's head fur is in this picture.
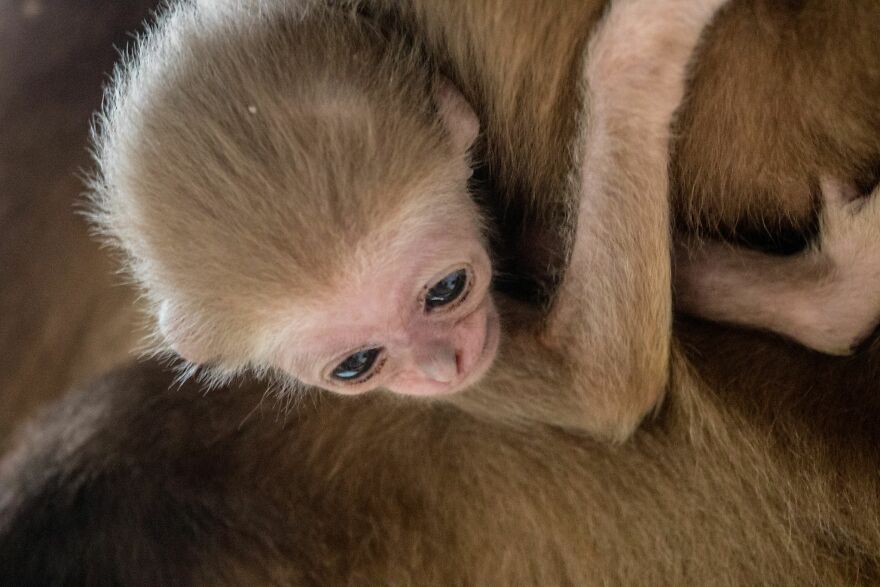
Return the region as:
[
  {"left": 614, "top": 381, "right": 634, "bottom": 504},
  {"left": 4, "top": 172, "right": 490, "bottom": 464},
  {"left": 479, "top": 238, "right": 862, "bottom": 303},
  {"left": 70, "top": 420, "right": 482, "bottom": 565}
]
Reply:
[{"left": 0, "top": 0, "right": 156, "bottom": 449}]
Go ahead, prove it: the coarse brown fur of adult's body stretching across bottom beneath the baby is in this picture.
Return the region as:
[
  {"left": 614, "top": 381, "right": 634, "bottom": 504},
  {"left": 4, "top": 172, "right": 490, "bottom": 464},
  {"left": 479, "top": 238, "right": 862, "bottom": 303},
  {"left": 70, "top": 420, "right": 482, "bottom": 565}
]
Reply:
[{"left": 0, "top": 0, "right": 880, "bottom": 584}]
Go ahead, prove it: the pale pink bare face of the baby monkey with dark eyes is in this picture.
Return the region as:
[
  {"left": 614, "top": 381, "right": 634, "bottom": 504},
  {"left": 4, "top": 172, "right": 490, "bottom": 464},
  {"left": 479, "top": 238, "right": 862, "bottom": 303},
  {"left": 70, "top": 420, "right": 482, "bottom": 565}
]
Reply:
[{"left": 279, "top": 227, "right": 500, "bottom": 396}]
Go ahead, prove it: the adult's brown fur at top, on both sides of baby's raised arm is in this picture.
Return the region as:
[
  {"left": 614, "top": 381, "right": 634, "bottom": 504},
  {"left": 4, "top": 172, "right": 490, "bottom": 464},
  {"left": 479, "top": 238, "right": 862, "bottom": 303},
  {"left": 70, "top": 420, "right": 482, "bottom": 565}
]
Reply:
[{"left": 372, "top": 0, "right": 880, "bottom": 284}]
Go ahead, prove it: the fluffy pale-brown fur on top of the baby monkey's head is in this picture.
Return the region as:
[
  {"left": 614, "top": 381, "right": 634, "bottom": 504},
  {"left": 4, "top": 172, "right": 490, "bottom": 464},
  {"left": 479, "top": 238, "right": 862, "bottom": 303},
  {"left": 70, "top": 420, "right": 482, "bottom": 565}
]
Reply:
[{"left": 91, "top": 2, "right": 477, "bottom": 372}]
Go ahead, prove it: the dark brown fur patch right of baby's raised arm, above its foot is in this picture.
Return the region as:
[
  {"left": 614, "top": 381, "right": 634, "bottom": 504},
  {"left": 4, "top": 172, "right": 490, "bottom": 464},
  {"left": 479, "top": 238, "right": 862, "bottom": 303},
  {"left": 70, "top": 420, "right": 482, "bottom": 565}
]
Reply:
[{"left": 673, "top": 0, "right": 880, "bottom": 239}]
